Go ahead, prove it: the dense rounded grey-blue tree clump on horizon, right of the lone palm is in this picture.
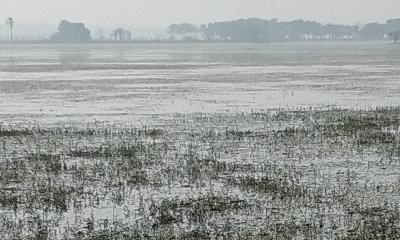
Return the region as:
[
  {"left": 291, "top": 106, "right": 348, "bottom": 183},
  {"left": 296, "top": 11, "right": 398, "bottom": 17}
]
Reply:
[{"left": 51, "top": 20, "right": 91, "bottom": 42}]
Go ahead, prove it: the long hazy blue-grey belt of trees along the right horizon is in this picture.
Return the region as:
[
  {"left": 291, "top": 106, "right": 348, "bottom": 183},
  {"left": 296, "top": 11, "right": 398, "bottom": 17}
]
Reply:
[{"left": 168, "top": 18, "right": 400, "bottom": 42}]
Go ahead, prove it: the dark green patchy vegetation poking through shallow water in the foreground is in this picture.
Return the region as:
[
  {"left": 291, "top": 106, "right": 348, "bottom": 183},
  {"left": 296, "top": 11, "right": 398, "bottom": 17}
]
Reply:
[{"left": 0, "top": 107, "right": 400, "bottom": 240}]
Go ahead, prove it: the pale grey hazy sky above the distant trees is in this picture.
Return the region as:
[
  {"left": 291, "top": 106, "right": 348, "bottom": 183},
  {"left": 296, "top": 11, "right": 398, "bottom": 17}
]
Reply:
[{"left": 0, "top": 0, "right": 400, "bottom": 26}]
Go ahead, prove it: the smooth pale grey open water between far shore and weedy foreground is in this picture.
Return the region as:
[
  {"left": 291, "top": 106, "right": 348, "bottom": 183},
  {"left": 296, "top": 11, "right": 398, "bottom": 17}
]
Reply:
[{"left": 0, "top": 42, "right": 400, "bottom": 122}]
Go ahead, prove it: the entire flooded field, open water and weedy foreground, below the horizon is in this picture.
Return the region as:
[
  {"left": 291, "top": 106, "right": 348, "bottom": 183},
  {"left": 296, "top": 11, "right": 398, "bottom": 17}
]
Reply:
[{"left": 0, "top": 42, "right": 400, "bottom": 240}]
